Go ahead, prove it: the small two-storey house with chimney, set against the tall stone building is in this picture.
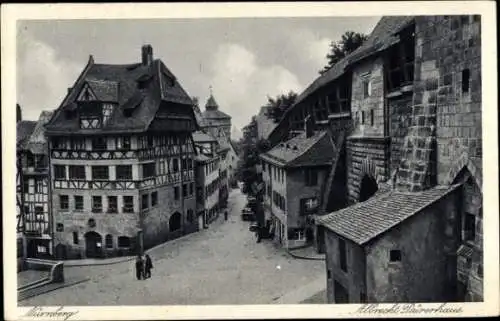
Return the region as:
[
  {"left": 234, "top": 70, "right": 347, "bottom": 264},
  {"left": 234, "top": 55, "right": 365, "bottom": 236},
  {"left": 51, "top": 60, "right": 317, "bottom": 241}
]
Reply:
[{"left": 260, "top": 117, "right": 337, "bottom": 248}]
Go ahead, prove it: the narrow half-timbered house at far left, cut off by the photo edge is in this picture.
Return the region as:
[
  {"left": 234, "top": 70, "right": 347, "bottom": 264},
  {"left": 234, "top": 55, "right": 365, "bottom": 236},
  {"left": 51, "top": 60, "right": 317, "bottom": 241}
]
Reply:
[{"left": 17, "top": 111, "right": 53, "bottom": 258}]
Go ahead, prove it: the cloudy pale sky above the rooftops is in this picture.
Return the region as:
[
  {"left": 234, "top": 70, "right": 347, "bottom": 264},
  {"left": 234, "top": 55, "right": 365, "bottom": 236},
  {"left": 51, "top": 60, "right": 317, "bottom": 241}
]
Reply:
[{"left": 17, "top": 17, "right": 380, "bottom": 138}]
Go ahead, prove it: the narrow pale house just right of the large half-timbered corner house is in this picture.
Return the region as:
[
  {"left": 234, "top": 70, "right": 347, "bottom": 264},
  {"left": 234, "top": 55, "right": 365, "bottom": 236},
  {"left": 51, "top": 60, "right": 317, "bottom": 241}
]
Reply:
[{"left": 193, "top": 131, "right": 221, "bottom": 228}]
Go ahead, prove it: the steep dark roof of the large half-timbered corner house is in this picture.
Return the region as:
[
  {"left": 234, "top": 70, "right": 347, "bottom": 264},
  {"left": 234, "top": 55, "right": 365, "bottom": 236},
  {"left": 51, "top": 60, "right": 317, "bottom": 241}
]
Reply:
[{"left": 47, "top": 57, "right": 194, "bottom": 134}]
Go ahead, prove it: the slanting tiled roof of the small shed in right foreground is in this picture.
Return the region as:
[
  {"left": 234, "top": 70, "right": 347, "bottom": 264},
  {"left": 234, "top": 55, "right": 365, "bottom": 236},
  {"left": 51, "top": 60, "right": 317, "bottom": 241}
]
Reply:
[{"left": 316, "top": 185, "right": 458, "bottom": 245}]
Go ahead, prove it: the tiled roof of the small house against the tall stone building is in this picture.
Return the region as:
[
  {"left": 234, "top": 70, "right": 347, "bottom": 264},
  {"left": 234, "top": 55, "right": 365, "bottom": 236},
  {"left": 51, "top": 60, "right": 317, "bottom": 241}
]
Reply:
[{"left": 261, "top": 131, "right": 337, "bottom": 167}]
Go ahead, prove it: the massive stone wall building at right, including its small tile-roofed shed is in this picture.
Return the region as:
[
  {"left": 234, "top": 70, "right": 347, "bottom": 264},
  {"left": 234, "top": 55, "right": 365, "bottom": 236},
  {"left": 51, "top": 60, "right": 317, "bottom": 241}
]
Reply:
[{"left": 269, "top": 15, "right": 483, "bottom": 303}]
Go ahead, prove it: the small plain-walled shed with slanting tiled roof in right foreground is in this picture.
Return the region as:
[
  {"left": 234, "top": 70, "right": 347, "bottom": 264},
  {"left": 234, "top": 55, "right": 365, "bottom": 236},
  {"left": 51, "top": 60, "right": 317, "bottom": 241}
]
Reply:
[{"left": 317, "top": 185, "right": 460, "bottom": 303}]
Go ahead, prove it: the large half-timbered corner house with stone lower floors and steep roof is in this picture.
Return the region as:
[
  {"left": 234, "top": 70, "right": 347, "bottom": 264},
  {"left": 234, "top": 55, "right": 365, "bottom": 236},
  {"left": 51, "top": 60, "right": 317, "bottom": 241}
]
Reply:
[{"left": 46, "top": 45, "right": 198, "bottom": 258}]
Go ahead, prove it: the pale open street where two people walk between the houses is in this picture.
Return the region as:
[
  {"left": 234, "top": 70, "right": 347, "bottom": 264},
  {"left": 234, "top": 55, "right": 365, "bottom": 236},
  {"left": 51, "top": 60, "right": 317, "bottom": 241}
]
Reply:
[{"left": 19, "top": 189, "right": 326, "bottom": 306}]
